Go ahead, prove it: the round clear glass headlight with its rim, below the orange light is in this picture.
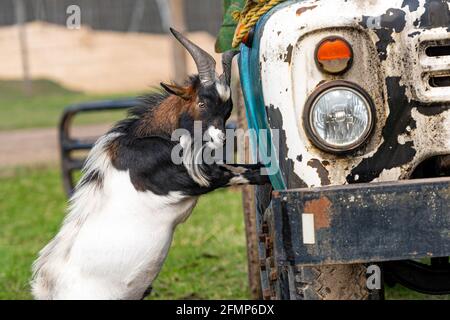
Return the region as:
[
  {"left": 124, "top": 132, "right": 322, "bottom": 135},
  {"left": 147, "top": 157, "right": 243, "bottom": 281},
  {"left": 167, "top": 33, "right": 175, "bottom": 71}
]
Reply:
[{"left": 304, "top": 81, "right": 375, "bottom": 152}]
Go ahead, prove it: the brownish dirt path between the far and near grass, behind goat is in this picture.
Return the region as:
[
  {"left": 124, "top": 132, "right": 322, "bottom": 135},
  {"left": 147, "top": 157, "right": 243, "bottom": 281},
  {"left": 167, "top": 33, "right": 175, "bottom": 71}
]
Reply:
[{"left": 0, "top": 125, "right": 109, "bottom": 167}]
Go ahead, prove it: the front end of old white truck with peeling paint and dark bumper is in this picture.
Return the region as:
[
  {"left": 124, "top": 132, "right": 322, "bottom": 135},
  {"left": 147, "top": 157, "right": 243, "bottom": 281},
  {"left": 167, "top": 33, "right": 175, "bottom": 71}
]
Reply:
[{"left": 239, "top": 0, "right": 450, "bottom": 299}]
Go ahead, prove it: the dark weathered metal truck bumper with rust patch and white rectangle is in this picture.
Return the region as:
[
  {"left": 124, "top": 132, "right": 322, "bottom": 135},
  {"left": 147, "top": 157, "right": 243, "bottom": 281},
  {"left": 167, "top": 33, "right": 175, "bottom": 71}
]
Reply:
[{"left": 262, "top": 178, "right": 450, "bottom": 266}]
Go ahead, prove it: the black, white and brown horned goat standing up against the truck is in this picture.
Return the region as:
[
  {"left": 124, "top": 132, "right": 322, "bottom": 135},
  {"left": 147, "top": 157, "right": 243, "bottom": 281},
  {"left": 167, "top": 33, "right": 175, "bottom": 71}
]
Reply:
[{"left": 31, "top": 30, "right": 268, "bottom": 299}]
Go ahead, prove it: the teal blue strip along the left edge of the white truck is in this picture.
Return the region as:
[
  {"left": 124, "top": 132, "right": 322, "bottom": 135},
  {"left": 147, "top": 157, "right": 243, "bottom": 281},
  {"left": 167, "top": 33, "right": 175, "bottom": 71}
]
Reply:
[{"left": 239, "top": 8, "right": 286, "bottom": 190}]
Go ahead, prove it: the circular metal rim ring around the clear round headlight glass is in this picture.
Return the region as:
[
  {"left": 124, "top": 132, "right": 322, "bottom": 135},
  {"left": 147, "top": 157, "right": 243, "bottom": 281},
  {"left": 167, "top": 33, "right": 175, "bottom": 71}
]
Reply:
[{"left": 303, "top": 80, "right": 376, "bottom": 154}]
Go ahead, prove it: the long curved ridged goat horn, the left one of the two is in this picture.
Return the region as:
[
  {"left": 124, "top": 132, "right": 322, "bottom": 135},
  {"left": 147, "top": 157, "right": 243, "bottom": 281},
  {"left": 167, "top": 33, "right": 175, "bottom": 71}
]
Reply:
[{"left": 170, "top": 28, "right": 216, "bottom": 85}]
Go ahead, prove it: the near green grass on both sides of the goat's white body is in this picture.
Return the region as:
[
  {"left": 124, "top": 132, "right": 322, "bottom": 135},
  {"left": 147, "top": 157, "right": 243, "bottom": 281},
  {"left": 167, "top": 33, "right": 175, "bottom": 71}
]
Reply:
[{"left": 0, "top": 167, "right": 450, "bottom": 299}]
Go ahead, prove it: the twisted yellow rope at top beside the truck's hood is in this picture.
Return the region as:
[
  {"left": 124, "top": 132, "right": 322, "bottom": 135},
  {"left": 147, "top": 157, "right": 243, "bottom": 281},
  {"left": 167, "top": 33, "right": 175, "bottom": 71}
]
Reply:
[{"left": 232, "top": 0, "right": 285, "bottom": 48}]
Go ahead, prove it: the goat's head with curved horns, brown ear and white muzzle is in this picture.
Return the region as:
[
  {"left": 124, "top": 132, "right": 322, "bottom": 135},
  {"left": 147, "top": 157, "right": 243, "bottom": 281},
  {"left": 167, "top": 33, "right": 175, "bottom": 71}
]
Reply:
[{"left": 161, "top": 29, "right": 237, "bottom": 147}]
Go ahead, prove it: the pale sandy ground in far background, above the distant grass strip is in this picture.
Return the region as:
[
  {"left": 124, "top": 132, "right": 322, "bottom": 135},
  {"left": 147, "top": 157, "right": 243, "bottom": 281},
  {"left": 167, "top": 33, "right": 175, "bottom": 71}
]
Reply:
[{"left": 0, "top": 22, "right": 220, "bottom": 93}]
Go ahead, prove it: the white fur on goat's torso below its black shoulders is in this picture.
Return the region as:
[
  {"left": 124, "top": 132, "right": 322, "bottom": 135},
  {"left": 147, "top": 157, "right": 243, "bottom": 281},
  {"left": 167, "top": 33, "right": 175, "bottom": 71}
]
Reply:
[{"left": 32, "top": 134, "right": 197, "bottom": 299}]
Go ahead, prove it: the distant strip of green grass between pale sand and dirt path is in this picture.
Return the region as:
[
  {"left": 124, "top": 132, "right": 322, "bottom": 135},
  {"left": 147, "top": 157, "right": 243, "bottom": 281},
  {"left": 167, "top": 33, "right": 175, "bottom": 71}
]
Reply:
[{"left": 0, "top": 80, "right": 144, "bottom": 130}]
